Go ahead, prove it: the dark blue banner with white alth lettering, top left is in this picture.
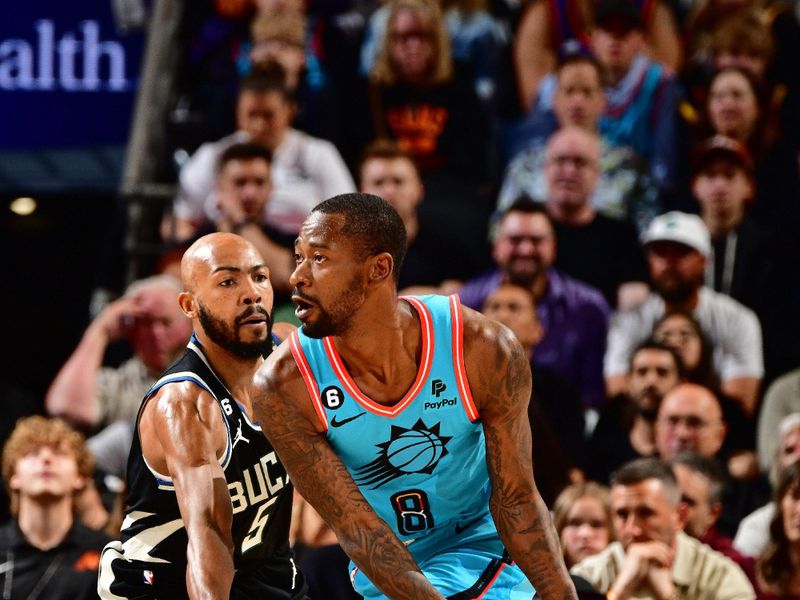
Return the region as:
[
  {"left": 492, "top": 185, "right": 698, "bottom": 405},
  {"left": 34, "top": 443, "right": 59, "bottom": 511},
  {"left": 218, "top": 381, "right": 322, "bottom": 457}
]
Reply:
[{"left": 0, "top": 0, "right": 144, "bottom": 151}]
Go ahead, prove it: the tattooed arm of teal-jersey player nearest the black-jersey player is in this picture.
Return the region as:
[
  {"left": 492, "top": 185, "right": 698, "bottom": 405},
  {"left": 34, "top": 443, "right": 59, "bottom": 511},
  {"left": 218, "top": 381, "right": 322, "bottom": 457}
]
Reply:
[{"left": 251, "top": 344, "right": 444, "bottom": 599}]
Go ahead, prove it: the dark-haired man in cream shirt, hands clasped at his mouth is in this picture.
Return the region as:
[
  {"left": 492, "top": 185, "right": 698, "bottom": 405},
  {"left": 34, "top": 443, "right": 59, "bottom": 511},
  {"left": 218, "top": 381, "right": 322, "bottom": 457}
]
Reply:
[{"left": 571, "top": 458, "right": 755, "bottom": 600}]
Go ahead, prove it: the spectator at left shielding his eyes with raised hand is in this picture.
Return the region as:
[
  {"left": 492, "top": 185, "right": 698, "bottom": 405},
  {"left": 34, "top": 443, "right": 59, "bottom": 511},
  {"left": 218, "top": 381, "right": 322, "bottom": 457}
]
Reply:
[{"left": 45, "top": 275, "right": 192, "bottom": 430}]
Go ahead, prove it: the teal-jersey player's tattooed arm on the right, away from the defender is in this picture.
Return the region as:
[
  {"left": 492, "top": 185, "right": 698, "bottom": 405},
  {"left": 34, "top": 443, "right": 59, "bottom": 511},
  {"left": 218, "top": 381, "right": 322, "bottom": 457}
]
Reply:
[{"left": 463, "top": 308, "right": 577, "bottom": 600}]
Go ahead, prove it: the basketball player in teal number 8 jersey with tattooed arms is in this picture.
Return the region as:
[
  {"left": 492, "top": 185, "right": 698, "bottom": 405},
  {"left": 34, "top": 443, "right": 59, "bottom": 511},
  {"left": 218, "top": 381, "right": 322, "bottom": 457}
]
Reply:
[{"left": 252, "top": 194, "right": 576, "bottom": 600}]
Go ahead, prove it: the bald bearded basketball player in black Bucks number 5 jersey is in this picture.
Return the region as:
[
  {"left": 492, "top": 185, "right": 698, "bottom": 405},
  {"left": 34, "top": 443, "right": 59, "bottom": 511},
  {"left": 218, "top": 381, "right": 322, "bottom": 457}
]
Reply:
[{"left": 98, "top": 233, "right": 306, "bottom": 600}]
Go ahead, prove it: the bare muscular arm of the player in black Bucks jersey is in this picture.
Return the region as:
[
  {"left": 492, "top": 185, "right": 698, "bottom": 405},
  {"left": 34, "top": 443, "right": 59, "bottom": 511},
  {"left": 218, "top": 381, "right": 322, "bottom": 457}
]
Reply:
[{"left": 142, "top": 382, "right": 234, "bottom": 600}]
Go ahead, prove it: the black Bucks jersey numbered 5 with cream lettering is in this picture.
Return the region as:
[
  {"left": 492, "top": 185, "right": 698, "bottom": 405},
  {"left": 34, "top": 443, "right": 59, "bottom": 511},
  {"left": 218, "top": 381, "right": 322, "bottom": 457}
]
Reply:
[{"left": 100, "top": 336, "right": 299, "bottom": 597}]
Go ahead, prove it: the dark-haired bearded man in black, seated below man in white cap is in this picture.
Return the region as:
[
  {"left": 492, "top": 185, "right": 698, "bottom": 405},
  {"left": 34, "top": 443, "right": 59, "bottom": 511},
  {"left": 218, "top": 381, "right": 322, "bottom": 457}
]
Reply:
[{"left": 586, "top": 340, "right": 684, "bottom": 484}]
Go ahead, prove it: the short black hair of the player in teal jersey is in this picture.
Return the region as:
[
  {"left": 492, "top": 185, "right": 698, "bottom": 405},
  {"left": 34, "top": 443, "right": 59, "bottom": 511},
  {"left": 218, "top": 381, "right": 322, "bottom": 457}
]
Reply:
[{"left": 311, "top": 192, "right": 407, "bottom": 283}]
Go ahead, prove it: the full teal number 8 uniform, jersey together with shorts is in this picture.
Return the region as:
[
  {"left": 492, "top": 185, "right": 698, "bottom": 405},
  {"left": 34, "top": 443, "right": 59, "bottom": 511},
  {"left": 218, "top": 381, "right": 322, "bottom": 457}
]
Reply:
[{"left": 289, "top": 296, "right": 534, "bottom": 600}]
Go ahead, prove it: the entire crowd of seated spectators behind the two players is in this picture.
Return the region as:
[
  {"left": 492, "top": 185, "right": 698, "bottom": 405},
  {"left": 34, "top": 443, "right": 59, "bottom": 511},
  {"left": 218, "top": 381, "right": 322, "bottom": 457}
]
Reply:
[{"left": 0, "top": 0, "right": 800, "bottom": 600}]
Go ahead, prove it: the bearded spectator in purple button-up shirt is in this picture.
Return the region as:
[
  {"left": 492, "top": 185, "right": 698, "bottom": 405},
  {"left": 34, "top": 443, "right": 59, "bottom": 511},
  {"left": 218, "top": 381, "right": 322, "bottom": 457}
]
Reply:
[{"left": 460, "top": 198, "right": 609, "bottom": 408}]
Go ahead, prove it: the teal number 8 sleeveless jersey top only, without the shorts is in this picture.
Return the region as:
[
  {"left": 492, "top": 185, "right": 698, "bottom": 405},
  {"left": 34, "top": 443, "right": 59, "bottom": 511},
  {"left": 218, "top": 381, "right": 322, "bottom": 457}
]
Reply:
[{"left": 290, "top": 296, "right": 499, "bottom": 554}]
